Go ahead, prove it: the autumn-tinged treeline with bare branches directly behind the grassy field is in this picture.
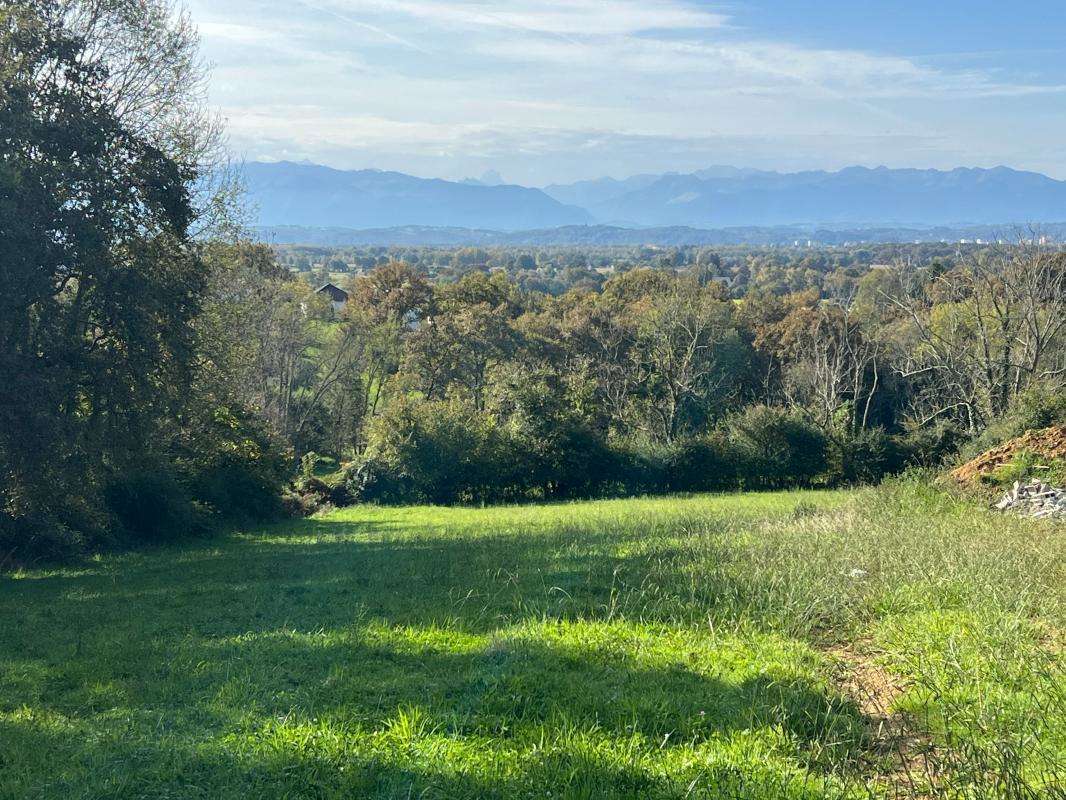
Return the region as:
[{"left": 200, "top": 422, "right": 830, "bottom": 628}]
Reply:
[{"left": 282, "top": 250, "right": 1066, "bottom": 502}]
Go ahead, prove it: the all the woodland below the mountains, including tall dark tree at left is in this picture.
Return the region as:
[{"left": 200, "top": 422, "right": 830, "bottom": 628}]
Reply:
[{"left": 0, "top": 0, "right": 1066, "bottom": 559}]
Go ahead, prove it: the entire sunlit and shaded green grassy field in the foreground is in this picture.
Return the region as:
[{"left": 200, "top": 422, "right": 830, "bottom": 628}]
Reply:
[{"left": 0, "top": 483, "right": 1066, "bottom": 799}]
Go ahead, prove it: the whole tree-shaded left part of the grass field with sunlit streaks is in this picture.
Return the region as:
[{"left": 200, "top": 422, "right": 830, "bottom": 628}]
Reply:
[{"left": 0, "top": 521, "right": 863, "bottom": 798}]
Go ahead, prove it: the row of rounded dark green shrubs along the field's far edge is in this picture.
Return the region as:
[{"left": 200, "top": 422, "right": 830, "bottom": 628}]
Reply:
[{"left": 328, "top": 398, "right": 902, "bottom": 506}]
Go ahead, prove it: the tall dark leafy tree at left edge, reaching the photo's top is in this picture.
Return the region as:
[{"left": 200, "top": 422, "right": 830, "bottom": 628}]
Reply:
[{"left": 0, "top": 0, "right": 214, "bottom": 546}]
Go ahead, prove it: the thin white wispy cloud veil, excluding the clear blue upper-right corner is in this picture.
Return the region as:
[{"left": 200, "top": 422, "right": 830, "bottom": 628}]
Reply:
[{"left": 190, "top": 0, "right": 1066, "bottom": 177}]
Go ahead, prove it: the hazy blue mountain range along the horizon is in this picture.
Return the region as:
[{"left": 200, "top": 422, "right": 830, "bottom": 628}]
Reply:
[{"left": 244, "top": 162, "right": 1066, "bottom": 231}]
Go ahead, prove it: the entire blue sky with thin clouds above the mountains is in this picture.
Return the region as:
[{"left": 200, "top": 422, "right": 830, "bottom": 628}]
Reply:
[{"left": 188, "top": 0, "right": 1066, "bottom": 186}]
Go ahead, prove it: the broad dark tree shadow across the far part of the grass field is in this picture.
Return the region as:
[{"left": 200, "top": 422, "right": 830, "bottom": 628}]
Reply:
[{"left": 0, "top": 521, "right": 686, "bottom": 641}]
